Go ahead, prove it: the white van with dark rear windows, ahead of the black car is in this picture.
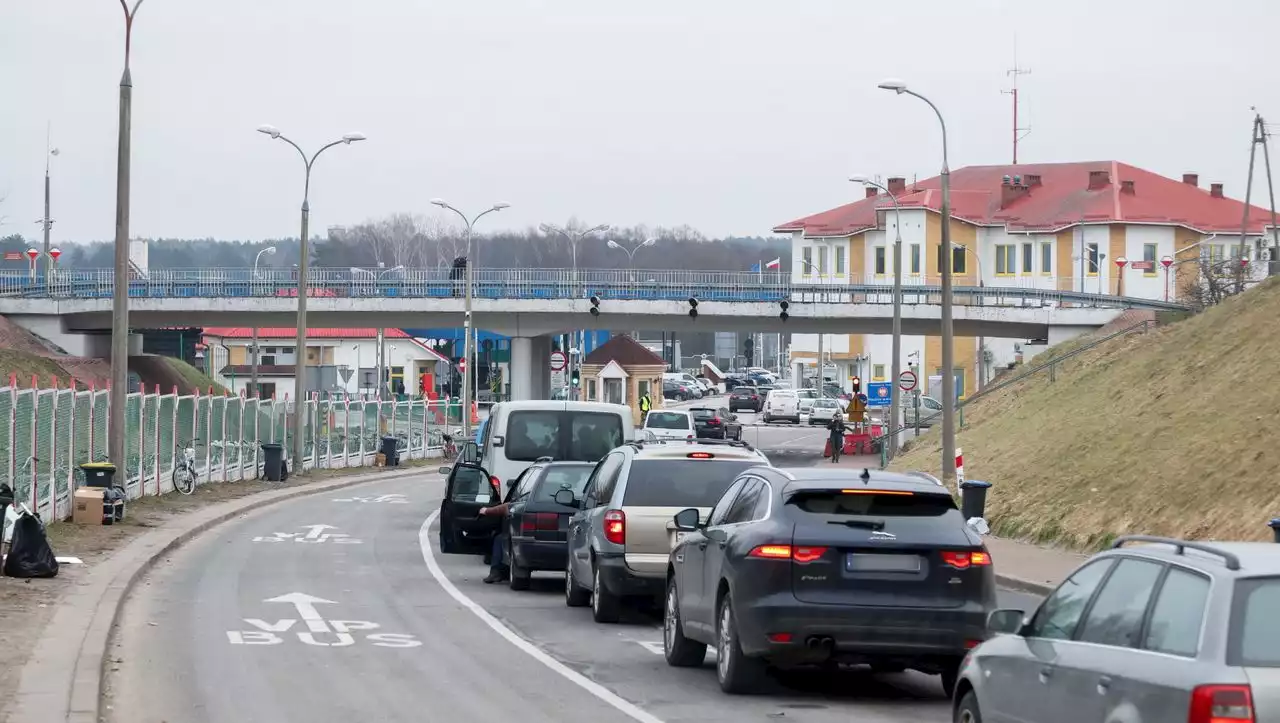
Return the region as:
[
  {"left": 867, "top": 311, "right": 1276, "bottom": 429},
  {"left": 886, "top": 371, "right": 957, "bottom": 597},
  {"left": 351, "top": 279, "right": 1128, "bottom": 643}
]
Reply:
[{"left": 479, "top": 399, "right": 635, "bottom": 489}]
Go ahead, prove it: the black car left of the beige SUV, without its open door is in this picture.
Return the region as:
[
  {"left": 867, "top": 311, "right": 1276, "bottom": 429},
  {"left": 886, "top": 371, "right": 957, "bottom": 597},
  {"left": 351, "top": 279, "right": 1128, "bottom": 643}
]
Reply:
[{"left": 503, "top": 462, "right": 595, "bottom": 590}]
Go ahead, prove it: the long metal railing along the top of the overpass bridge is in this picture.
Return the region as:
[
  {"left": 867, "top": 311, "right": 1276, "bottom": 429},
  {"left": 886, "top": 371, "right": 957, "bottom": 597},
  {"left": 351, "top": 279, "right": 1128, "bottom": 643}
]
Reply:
[{"left": 0, "top": 267, "right": 1187, "bottom": 310}]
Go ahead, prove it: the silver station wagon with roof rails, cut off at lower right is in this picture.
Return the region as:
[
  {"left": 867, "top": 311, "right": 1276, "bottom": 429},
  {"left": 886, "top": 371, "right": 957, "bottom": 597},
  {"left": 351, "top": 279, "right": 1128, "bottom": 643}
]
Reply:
[{"left": 954, "top": 536, "right": 1280, "bottom": 723}]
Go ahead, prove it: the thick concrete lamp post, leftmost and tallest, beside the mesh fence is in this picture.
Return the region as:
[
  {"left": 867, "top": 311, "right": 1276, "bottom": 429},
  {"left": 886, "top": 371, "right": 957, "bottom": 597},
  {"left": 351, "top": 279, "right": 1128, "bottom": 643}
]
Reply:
[{"left": 106, "top": 0, "right": 142, "bottom": 473}]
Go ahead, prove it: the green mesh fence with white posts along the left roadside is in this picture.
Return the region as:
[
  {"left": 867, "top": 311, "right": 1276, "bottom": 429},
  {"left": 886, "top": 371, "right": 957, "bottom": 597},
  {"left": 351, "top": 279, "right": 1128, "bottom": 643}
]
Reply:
[{"left": 0, "top": 383, "right": 461, "bottom": 520}]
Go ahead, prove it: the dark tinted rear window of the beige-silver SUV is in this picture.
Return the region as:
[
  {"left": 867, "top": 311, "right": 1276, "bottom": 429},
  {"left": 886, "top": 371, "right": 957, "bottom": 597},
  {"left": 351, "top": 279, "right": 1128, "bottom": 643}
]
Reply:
[{"left": 622, "top": 459, "right": 760, "bottom": 508}]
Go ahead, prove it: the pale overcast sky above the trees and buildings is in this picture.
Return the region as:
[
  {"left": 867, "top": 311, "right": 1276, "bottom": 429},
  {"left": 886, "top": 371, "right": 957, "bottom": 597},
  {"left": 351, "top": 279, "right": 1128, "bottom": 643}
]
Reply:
[{"left": 0, "top": 0, "right": 1280, "bottom": 244}]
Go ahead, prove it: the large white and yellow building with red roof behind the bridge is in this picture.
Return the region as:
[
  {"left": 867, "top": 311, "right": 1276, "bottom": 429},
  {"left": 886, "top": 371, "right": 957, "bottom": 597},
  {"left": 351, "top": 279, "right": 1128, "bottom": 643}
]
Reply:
[{"left": 773, "top": 161, "right": 1275, "bottom": 397}]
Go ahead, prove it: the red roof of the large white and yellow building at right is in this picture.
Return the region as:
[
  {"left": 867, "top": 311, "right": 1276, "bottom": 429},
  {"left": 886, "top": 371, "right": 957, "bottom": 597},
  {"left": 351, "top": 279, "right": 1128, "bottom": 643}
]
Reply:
[{"left": 773, "top": 161, "right": 1271, "bottom": 237}]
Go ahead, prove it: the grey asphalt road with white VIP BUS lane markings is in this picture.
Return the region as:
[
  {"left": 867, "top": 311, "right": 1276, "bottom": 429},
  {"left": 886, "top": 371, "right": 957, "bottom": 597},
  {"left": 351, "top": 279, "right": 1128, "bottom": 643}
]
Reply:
[{"left": 108, "top": 463, "right": 1033, "bottom": 723}]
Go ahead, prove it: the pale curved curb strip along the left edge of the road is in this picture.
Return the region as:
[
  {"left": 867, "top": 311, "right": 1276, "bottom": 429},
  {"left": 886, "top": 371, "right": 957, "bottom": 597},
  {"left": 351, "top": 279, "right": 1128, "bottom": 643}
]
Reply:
[{"left": 8, "top": 467, "right": 435, "bottom": 723}]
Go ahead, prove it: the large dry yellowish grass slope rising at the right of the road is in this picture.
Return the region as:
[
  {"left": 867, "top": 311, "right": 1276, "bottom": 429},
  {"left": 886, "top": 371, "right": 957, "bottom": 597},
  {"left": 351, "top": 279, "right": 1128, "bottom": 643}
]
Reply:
[{"left": 893, "top": 279, "right": 1280, "bottom": 549}]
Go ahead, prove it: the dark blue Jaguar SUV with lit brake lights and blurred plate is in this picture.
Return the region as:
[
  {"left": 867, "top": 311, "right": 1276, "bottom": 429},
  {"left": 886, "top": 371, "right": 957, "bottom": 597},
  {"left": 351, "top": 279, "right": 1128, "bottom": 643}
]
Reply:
[{"left": 663, "top": 467, "right": 996, "bottom": 696}]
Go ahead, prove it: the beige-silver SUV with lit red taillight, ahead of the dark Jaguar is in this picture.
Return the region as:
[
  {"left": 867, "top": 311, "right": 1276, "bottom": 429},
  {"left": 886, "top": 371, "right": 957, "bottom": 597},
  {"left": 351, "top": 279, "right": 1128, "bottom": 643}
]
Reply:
[{"left": 564, "top": 439, "right": 769, "bottom": 623}]
